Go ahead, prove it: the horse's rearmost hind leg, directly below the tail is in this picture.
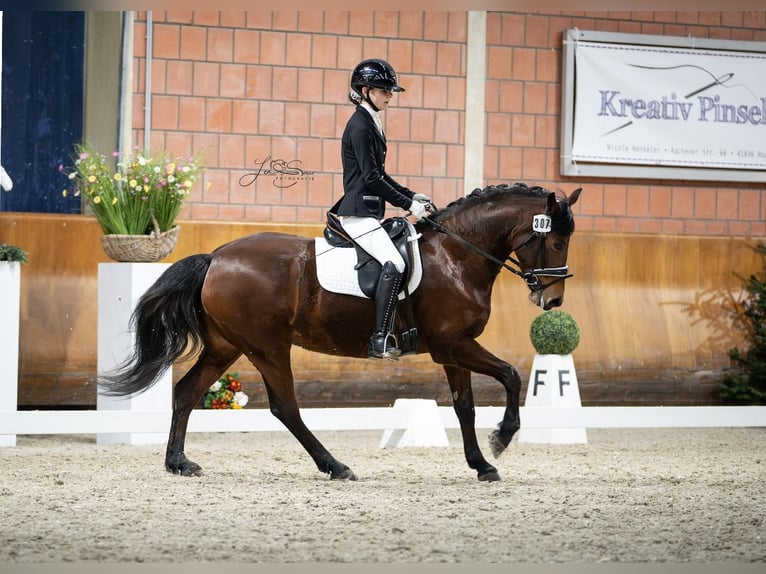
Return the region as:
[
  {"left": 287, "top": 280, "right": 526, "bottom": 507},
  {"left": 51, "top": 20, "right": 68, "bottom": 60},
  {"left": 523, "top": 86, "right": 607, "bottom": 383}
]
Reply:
[{"left": 165, "top": 350, "right": 241, "bottom": 476}]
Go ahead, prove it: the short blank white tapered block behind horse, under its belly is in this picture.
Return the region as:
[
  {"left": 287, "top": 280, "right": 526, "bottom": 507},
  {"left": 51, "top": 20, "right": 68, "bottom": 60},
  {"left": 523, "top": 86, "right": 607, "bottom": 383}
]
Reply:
[{"left": 380, "top": 399, "right": 449, "bottom": 448}]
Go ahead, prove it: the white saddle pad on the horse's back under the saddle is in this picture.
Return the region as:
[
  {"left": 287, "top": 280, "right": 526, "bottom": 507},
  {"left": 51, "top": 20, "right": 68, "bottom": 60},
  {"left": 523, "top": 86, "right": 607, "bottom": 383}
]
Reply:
[{"left": 314, "top": 221, "right": 423, "bottom": 299}]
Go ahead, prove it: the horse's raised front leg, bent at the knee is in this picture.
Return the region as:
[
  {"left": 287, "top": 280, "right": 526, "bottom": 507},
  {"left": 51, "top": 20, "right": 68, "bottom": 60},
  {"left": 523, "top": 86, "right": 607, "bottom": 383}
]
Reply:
[{"left": 444, "top": 339, "right": 521, "bottom": 464}]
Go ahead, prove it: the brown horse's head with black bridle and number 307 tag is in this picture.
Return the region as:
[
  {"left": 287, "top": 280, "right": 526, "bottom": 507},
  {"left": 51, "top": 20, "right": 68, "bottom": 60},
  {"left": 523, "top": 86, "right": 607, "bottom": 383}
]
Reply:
[{"left": 511, "top": 188, "right": 582, "bottom": 311}]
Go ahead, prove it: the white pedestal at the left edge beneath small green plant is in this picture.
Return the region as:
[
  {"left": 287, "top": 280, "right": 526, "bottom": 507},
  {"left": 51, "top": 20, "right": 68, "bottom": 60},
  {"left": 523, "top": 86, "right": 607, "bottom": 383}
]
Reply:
[{"left": 0, "top": 261, "right": 21, "bottom": 446}]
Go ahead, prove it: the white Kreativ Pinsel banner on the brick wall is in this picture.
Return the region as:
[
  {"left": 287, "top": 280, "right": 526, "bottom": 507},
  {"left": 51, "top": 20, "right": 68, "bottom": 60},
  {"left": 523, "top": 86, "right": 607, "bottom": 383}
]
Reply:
[{"left": 572, "top": 42, "right": 766, "bottom": 170}]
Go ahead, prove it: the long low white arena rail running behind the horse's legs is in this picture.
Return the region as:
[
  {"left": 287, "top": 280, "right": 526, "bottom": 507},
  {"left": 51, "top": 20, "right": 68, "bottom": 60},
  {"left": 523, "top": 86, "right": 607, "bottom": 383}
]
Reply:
[{"left": 0, "top": 408, "right": 766, "bottom": 435}]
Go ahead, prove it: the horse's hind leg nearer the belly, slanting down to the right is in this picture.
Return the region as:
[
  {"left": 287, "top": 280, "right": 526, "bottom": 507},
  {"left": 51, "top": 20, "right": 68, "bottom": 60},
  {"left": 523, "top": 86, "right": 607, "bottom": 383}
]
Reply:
[{"left": 252, "top": 348, "right": 356, "bottom": 480}]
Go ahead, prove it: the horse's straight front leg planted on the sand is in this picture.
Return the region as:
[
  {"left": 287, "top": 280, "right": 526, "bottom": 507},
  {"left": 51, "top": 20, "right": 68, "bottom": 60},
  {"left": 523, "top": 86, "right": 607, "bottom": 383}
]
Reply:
[{"left": 444, "top": 365, "right": 500, "bottom": 481}]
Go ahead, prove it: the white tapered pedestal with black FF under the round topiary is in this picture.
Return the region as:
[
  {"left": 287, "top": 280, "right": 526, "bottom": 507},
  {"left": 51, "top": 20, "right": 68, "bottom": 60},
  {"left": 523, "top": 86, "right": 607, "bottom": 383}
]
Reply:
[{"left": 518, "top": 355, "right": 588, "bottom": 444}]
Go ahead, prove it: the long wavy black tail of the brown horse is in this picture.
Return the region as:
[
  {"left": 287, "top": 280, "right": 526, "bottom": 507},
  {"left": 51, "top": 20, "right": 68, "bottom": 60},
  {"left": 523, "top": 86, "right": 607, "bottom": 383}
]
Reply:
[{"left": 98, "top": 254, "right": 212, "bottom": 396}]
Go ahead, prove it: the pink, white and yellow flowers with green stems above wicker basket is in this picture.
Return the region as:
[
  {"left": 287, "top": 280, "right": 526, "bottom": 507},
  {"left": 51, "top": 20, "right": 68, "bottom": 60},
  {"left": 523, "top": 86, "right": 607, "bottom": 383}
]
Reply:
[{"left": 59, "top": 144, "right": 204, "bottom": 235}]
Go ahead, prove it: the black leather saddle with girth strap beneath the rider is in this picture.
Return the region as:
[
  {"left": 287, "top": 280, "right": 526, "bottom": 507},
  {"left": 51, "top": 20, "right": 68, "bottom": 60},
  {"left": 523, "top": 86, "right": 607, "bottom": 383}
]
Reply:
[{"left": 320, "top": 211, "right": 420, "bottom": 355}]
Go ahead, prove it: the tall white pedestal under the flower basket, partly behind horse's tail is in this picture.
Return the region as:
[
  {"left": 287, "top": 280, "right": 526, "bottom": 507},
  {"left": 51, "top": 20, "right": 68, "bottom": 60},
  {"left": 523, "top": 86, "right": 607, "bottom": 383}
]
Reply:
[{"left": 96, "top": 263, "right": 173, "bottom": 445}]
